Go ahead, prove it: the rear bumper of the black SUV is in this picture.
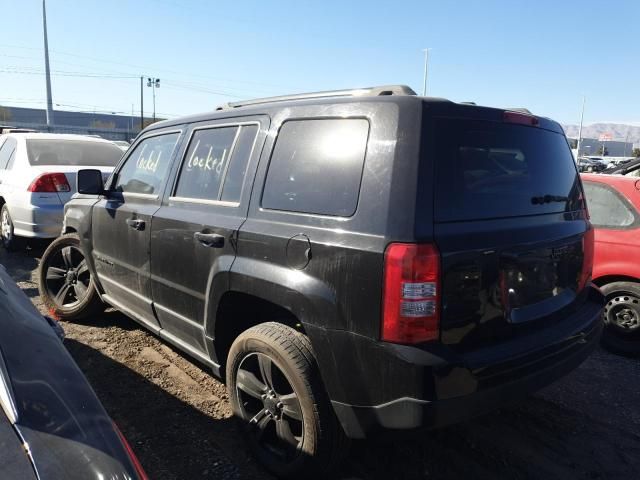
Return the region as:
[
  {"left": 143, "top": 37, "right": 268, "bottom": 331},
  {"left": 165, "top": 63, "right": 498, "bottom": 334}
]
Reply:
[{"left": 322, "top": 287, "right": 604, "bottom": 438}]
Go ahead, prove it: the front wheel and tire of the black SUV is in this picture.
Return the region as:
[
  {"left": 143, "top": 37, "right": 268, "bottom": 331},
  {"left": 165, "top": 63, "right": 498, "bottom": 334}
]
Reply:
[{"left": 38, "top": 233, "right": 105, "bottom": 320}]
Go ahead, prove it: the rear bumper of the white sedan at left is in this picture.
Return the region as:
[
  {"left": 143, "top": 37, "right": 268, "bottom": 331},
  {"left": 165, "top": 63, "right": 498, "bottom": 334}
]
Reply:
[{"left": 10, "top": 204, "right": 64, "bottom": 238}]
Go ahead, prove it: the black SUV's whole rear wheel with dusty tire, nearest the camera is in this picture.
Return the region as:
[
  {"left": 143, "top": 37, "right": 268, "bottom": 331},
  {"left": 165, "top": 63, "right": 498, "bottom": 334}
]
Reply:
[{"left": 226, "top": 322, "right": 348, "bottom": 478}]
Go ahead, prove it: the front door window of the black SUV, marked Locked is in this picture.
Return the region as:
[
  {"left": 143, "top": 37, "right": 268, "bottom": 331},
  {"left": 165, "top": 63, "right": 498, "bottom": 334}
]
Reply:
[{"left": 114, "top": 132, "right": 180, "bottom": 195}]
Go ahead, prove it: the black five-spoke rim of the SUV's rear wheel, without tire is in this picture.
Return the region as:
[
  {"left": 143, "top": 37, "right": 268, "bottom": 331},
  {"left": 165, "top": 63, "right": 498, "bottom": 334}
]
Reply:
[{"left": 235, "top": 352, "right": 304, "bottom": 462}]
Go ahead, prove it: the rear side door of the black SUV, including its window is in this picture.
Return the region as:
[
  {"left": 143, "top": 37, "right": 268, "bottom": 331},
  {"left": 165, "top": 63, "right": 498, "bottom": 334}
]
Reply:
[{"left": 151, "top": 117, "right": 268, "bottom": 358}]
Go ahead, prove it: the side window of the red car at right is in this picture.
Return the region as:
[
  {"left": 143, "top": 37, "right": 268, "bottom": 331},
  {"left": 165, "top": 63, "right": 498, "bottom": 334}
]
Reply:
[{"left": 583, "top": 182, "right": 638, "bottom": 229}]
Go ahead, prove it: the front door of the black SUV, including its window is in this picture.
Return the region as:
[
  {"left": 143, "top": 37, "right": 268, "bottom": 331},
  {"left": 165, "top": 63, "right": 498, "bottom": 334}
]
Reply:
[{"left": 92, "top": 129, "right": 181, "bottom": 331}]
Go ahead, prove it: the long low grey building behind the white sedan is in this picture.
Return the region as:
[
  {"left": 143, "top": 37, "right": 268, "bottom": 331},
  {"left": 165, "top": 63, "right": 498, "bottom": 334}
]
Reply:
[{"left": 0, "top": 106, "right": 160, "bottom": 141}]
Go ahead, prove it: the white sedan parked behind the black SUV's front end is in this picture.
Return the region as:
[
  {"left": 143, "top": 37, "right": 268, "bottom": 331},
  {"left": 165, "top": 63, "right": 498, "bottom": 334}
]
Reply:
[{"left": 0, "top": 133, "right": 122, "bottom": 250}]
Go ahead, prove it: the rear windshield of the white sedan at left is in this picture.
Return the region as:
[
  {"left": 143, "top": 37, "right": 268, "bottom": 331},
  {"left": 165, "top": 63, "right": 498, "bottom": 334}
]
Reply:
[{"left": 27, "top": 139, "right": 123, "bottom": 167}]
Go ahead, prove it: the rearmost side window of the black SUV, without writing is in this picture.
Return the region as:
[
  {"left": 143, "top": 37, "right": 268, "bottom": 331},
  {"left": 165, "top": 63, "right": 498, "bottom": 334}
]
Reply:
[{"left": 262, "top": 119, "right": 369, "bottom": 217}]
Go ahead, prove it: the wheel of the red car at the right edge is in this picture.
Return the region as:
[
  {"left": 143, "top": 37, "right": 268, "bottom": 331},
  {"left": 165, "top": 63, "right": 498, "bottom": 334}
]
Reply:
[{"left": 601, "top": 282, "right": 640, "bottom": 357}]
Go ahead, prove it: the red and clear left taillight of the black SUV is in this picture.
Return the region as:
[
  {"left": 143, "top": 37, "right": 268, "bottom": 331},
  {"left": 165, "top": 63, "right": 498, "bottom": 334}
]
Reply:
[{"left": 382, "top": 243, "right": 440, "bottom": 343}]
